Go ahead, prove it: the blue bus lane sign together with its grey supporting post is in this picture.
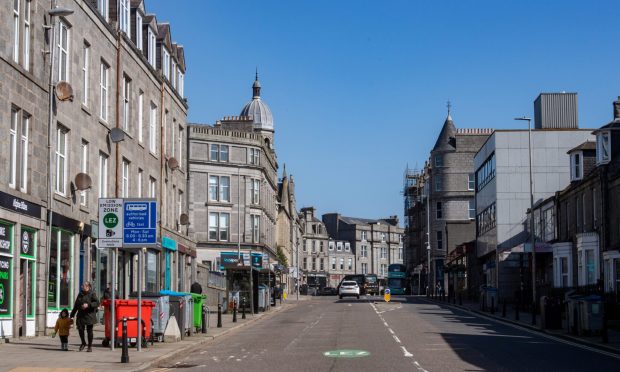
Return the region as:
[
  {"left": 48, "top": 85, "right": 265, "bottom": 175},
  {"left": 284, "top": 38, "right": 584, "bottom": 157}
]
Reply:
[{"left": 123, "top": 198, "right": 157, "bottom": 351}]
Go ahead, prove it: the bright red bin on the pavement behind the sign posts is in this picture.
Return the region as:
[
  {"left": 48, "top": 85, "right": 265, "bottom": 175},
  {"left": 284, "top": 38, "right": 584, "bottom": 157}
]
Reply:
[{"left": 102, "top": 299, "right": 155, "bottom": 347}]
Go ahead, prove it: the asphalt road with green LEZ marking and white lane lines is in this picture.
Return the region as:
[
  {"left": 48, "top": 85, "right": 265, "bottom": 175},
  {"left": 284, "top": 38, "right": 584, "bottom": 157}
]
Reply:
[{"left": 156, "top": 297, "right": 620, "bottom": 372}]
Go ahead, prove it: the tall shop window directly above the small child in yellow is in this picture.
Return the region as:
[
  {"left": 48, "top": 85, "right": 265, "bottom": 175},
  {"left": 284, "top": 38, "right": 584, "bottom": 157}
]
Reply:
[{"left": 47, "top": 229, "right": 73, "bottom": 309}]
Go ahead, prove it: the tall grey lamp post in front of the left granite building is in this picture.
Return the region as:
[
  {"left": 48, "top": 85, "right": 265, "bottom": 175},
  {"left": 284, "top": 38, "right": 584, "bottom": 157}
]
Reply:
[{"left": 45, "top": 2, "right": 73, "bottom": 336}]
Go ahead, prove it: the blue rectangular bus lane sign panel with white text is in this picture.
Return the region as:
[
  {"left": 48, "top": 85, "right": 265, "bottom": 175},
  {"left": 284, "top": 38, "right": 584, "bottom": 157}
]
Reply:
[{"left": 123, "top": 199, "right": 157, "bottom": 248}]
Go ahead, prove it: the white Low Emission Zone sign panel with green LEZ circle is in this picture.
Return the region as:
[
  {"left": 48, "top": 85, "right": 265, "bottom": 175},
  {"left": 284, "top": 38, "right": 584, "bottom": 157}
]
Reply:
[{"left": 97, "top": 198, "right": 123, "bottom": 248}]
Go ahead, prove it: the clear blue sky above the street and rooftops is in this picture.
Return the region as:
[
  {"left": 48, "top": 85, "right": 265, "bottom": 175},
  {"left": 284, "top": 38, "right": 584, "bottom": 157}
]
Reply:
[{"left": 146, "top": 0, "right": 620, "bottom": 224}]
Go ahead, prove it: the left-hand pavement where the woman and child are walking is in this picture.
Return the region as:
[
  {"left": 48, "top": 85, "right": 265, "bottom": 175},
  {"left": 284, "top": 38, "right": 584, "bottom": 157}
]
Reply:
[{"left": 0, "top": 296, "right": 302, "bottom": 372}]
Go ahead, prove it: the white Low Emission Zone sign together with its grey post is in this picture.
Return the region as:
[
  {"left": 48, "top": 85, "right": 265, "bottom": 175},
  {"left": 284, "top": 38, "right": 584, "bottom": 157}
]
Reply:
[{"left": 97, "top": 198, "right": 123, "bottom": 350}]
